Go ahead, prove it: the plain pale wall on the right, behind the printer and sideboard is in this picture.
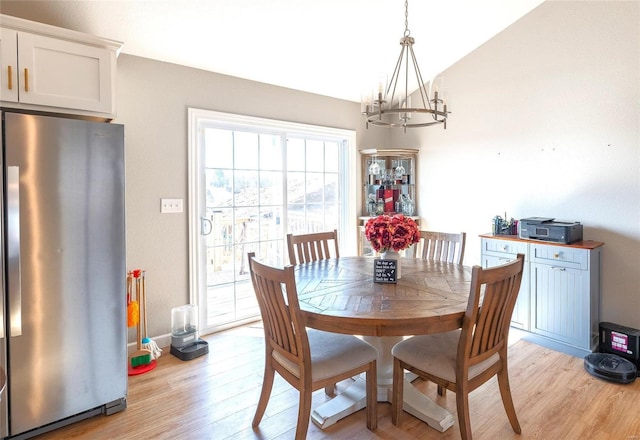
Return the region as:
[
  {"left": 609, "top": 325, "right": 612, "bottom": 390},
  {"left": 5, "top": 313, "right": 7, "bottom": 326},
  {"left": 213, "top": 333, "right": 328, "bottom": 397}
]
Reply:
[{"left": 394, "top": 1, "right": 640, "bottom": 328}]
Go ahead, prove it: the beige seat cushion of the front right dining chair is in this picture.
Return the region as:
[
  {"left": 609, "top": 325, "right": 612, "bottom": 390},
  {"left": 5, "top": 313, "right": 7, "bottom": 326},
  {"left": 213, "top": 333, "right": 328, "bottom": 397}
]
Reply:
[{"left": 391, "top": 330, "right": 500, "bottom": 383}]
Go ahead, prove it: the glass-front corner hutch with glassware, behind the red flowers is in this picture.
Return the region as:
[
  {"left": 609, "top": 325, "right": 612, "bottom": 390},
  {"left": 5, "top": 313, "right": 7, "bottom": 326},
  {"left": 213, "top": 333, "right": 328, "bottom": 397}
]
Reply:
[{"left": 358, "top": 148, "right": 419, "bottom": 255}]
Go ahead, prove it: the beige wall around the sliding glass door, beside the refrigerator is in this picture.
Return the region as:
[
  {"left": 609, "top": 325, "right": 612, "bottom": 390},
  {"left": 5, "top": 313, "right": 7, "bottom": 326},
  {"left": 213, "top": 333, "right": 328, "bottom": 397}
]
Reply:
[{"left": 115, "top": 55, "right": 364, "bottom": 341}]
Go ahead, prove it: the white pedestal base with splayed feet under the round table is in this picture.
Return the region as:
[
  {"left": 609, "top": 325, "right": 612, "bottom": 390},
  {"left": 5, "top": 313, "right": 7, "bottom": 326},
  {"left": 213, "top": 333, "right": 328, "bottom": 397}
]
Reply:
[{"left": 311, "top": 336, "right": 454, "bottom": 432}]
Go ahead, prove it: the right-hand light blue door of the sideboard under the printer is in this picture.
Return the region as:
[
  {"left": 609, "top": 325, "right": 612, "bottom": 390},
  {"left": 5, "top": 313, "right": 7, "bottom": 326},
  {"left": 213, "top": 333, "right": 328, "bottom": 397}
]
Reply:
[{"left": 531, "top": 263, "right": 590, "bottom": 349}]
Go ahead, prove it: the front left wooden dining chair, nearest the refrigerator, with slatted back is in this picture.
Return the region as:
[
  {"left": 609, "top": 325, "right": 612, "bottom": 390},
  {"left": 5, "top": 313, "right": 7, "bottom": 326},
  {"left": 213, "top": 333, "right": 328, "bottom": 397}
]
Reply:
[{"left": 248, "top": 252, "right": 378, "bottom": 440}]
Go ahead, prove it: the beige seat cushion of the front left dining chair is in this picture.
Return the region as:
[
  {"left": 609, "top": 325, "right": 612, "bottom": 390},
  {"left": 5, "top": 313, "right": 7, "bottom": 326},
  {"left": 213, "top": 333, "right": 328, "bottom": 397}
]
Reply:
[{"left": 273, "top": 329, "right": 378, "bottom": 381}]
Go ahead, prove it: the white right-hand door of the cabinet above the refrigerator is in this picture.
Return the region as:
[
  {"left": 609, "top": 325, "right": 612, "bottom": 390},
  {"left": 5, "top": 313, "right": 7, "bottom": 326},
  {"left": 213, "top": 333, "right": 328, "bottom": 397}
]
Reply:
[{"left": 18, "top": 32, "right": 115, "bottom": 113}]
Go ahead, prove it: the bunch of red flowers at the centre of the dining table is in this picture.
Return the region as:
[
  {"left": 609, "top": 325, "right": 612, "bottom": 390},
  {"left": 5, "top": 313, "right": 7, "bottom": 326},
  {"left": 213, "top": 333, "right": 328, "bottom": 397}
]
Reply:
[{"left": 364, "top": 214, "right": 420, "bottom": 252}]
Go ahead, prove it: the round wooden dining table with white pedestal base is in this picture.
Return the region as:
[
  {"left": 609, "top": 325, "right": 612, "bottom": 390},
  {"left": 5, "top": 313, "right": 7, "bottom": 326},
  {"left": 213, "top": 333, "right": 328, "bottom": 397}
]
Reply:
[{"left": 295, "top": 257, "right": 471, "bottom": 432}]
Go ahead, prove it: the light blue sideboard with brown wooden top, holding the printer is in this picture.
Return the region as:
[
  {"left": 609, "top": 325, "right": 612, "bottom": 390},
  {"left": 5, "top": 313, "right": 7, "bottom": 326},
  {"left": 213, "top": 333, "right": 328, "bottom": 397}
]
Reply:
[{"left": 481, "top": 234, "right": 604, "bottom": 357}]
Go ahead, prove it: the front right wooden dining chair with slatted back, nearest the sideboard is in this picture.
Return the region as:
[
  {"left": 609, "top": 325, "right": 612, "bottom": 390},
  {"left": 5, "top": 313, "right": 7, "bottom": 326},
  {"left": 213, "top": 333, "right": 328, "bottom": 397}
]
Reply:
[{"left": 391, "top": 254, "right": 524, "bottom": 440}]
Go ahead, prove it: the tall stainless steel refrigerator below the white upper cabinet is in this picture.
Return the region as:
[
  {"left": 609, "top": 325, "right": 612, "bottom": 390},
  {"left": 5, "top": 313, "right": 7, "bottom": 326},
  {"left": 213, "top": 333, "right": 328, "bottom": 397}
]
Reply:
[{"left": 0, "top": 111, "right": 127, "bottom": 438}]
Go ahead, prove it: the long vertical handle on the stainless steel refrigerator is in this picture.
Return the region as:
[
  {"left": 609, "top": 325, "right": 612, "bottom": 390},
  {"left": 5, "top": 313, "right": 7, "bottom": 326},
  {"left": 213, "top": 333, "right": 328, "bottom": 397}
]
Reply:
[{"left": 7, "top": 166, "right": 22, "bottom": 338}]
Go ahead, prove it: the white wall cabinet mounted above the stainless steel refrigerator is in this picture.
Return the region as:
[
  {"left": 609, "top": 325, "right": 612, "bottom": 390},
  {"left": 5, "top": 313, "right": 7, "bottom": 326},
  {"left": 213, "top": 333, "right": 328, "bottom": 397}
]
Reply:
[{"left": 0, "top": 15, "right": 122, "bottom": 119}]
